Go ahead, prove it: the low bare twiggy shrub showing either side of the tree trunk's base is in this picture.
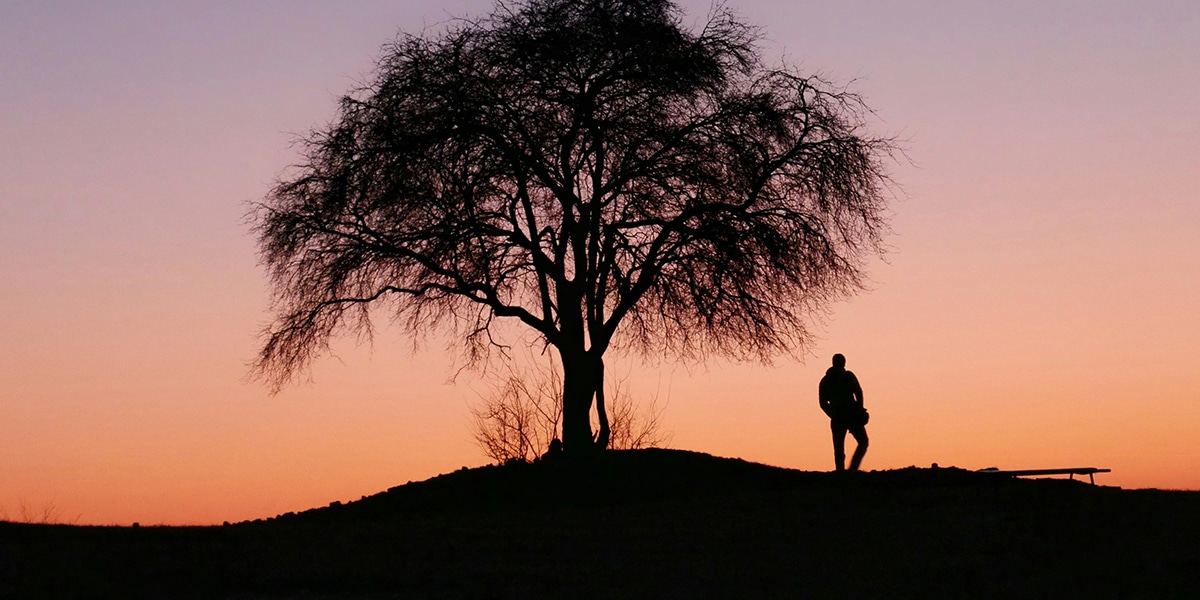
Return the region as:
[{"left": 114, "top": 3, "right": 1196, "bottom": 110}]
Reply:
[{"left": 472, "top": 355, "right": 671, "bottom": 464}]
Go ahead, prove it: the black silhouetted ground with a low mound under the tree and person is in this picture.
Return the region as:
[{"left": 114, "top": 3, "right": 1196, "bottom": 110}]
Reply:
[{"left": 0, "top": 450, "right": 1200, "bottom": 599}]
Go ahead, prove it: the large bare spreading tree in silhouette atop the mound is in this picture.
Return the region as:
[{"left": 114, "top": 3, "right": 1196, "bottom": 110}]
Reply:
[{"left": 254, "top": 0, "right": 895, "bottom": 452}]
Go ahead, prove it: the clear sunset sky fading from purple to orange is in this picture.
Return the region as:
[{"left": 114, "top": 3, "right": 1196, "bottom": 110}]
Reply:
[{"left": 0, "top": 0, "right": 1200, "bottom": 524}]
